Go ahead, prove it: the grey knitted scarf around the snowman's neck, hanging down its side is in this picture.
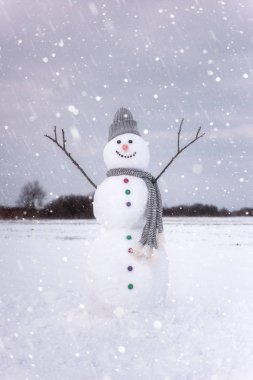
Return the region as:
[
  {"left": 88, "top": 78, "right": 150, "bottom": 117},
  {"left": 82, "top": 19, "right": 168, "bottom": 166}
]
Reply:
[{"left": 107, "top": 168, "right": 163, "bottom": 249}]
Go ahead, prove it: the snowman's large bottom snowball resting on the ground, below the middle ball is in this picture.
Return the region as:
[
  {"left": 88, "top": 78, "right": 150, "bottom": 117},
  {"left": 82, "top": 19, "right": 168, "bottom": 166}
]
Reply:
[{"left": 86, "top": 229, "right": 167, "bottom": 310}]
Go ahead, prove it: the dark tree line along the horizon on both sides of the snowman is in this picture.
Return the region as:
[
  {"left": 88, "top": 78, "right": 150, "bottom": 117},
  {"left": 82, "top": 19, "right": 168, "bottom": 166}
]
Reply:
[{"left": 0, "top": 181, "right": 253, "bottom": 219}]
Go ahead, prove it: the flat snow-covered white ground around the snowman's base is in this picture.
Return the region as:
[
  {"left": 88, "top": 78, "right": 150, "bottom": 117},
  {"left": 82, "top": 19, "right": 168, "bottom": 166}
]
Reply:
[{"left": 0, "top": 218, "right": 253, "bottom": 380}]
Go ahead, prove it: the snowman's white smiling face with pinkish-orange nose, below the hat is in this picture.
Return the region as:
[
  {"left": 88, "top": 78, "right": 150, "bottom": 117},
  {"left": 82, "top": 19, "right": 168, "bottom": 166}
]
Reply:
[{"left": 104, "top": 133, "right": 149, "bottom": 170}]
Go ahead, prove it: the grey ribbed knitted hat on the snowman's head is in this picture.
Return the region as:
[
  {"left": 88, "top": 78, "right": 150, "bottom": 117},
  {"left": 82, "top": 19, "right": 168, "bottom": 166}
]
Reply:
[{"left": 108, "top": 107, "right": 140, "bottom": 141}]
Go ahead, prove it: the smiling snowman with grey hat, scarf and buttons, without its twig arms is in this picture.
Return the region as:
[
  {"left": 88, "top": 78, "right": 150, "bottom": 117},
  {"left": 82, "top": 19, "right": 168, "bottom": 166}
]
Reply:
[{"left": 86, "top": 108, "right": 168, "bottom": 311}]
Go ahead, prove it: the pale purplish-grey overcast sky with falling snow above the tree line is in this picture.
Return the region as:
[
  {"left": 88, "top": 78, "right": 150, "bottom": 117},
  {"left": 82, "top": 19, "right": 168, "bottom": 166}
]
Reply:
[{"left": 0, "top": 0, "right": 253, "bottom": 209}]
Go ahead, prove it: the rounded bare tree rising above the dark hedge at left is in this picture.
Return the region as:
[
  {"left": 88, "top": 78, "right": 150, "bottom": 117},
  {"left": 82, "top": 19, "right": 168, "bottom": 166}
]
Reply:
[{"left": 17, "top": 181, "right": 46, "bottom": 209}]
